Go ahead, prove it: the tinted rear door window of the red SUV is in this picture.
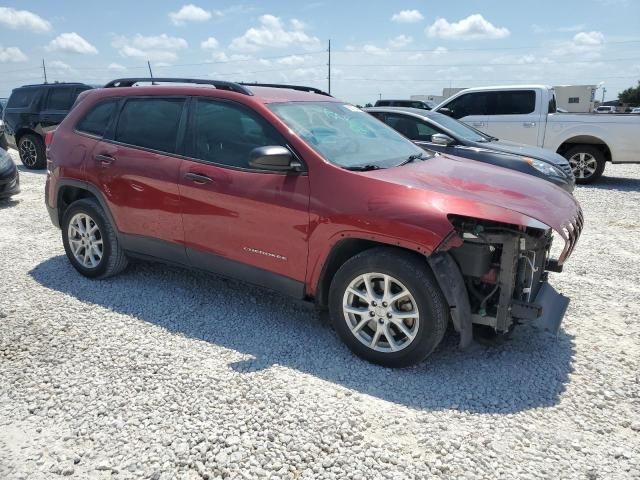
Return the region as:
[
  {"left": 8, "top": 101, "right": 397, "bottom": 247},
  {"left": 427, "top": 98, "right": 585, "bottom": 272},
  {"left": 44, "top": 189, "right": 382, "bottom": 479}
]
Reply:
[{"left": 115, "top": 98, "right": 184, "bottom": 153}]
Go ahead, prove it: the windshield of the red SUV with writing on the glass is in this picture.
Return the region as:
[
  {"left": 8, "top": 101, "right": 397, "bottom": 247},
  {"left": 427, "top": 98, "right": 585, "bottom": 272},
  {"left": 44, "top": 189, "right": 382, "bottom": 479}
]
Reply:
[{"left": 268, "top": 102, "right": 428, "bottom": 168}]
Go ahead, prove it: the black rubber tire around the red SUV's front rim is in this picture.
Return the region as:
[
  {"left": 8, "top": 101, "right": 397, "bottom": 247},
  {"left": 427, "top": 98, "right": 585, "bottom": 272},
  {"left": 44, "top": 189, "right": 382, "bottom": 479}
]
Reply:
[{"left": 329, "top": 247, "right": 449, "bottom": 367}]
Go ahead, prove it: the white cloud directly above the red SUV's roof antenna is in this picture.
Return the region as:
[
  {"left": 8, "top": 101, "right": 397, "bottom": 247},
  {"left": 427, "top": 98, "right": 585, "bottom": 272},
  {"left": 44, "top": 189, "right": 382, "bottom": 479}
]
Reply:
[{"left": 111, "top": 33, "right": 189, "bottom": 62}]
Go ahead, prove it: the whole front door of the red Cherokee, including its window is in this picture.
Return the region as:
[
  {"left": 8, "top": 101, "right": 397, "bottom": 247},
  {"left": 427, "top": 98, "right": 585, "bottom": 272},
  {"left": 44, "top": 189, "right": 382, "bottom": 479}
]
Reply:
[{"left": 179, "top": 98, "right": 309, "bottom": 295}]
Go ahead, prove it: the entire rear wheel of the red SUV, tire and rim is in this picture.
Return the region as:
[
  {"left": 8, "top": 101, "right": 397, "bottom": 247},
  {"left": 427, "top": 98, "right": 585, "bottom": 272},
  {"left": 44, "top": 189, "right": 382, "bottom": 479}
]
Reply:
[{"left": 62, "top": 198, "right": 127, "bottom": 278}]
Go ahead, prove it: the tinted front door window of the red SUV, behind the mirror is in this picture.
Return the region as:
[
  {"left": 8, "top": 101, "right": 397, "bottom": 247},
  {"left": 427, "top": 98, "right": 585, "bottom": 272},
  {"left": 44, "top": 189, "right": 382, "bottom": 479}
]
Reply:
[{"left": 193, "top": 100, "right": 285, "bottom": 168}]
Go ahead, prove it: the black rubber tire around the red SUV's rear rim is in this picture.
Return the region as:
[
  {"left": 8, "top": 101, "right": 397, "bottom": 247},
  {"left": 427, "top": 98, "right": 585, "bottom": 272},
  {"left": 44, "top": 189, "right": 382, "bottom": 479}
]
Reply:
[{"left": 62, "top": 198, "right": 128, "bottom": 278}]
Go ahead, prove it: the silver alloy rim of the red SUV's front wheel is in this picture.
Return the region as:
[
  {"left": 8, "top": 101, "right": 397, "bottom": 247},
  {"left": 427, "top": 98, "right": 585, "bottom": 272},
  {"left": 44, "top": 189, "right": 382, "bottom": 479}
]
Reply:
[{"left": 342, "top": 272, "right": 420, "bottom": 353}]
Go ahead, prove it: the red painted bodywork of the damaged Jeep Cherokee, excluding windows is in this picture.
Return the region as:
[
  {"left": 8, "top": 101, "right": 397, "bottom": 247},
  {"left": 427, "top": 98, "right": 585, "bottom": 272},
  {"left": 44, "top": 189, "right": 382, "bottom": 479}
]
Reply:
[{"left": 47, "top": 86, "right": 580, "bottom": 296}]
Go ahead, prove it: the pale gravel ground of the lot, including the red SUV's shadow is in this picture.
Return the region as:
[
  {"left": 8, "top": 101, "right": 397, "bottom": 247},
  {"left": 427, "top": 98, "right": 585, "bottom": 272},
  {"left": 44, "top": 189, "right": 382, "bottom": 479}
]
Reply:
[{"left": 0, "top": 152, "right": 640, "bottom": 480}]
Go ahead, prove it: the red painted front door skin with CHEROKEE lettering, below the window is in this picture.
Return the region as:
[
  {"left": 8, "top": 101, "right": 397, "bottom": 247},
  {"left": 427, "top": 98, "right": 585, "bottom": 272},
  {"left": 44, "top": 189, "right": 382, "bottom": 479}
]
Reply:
[{"left": 180, "top": 160, "right": 309, "bottom": 282}]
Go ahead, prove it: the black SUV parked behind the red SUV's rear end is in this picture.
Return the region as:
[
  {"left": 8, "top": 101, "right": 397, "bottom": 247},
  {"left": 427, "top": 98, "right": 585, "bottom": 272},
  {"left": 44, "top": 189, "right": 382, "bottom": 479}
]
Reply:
[{"left": 0, "top": 83, "right": 92, "bottom": 169}]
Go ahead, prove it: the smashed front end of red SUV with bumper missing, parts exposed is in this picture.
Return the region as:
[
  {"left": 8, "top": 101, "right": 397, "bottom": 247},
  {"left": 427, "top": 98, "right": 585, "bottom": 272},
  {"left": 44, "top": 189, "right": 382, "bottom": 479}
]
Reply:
[{"left": 429, "top": 210, "right": 583, "bottom": 347}]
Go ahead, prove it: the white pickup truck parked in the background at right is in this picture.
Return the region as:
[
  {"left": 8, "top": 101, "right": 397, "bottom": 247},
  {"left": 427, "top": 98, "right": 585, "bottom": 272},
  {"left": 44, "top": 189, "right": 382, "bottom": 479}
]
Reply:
[{"left": 433, "top": 85, "right": 640, "bottom": 183}]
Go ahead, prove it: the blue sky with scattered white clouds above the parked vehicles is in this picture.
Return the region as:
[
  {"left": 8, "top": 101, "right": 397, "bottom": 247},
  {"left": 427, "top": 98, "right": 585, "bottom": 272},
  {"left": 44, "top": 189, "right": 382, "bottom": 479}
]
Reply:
[{"left": 0, "top": 0, "right": 640, "bottom": 104}]
